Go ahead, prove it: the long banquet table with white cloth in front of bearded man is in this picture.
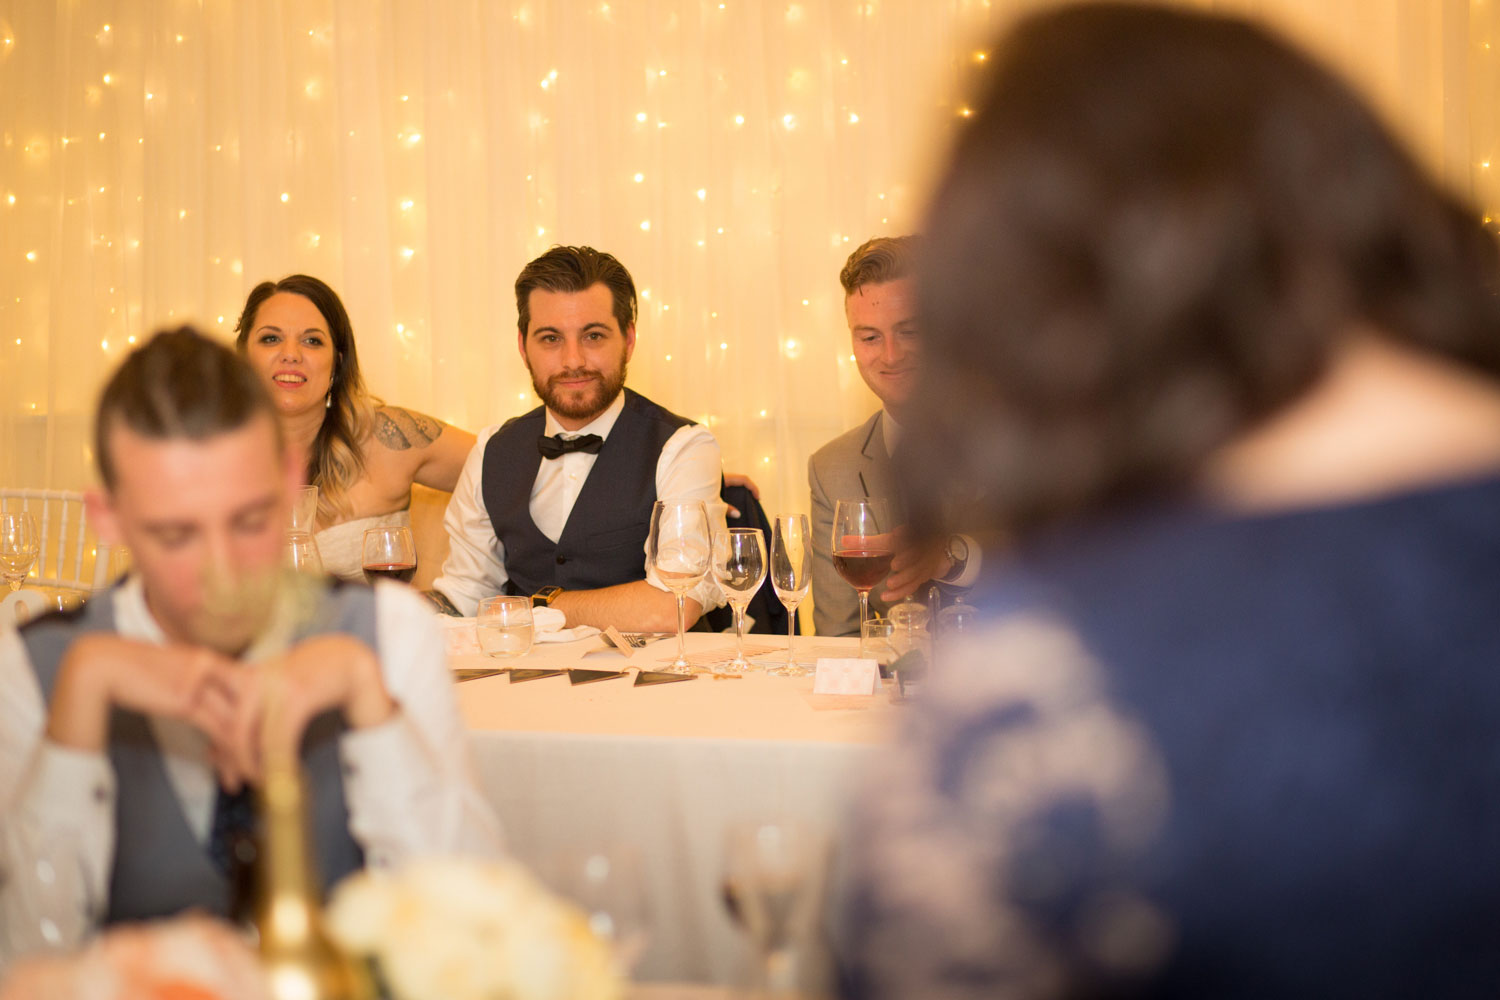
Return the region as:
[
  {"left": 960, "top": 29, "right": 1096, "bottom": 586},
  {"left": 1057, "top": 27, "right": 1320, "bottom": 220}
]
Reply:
[{"left": 450, "top": 633, "right": 905, "bottom": 985}]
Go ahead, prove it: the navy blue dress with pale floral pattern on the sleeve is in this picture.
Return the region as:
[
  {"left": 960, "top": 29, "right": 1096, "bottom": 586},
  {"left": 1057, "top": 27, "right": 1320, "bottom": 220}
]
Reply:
[{"left": 846, "top": 478, "right": 1500, "bottom": 999}]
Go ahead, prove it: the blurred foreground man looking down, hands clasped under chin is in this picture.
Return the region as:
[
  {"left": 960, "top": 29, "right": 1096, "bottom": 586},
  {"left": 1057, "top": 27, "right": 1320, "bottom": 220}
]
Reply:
[{"left": 0, "top": 328, "right": 500, "bottom": 970}]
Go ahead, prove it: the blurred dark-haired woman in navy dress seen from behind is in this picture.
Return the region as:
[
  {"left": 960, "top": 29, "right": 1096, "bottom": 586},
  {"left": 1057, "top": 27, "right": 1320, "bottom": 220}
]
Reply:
[{"left": 849, "top": 4, "right": 1500, "bottom": 1000}]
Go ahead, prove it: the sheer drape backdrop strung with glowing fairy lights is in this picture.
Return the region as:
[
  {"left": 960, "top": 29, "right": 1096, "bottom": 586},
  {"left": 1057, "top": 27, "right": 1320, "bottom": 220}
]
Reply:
[{"left": 0, "top": 0, "right": 1500, "bottom": 524}]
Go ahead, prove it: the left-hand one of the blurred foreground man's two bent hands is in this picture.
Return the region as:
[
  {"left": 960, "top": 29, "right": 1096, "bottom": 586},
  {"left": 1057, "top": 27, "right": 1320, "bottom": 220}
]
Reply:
[{"left": 47, "top": 633, "right": 239, "bottom": 753}]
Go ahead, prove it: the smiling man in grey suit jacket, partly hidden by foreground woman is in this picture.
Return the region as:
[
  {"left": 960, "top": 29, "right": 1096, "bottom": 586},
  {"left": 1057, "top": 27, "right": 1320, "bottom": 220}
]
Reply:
[{"left": 807, "top": 235, "right": 980, "bottom": 636}]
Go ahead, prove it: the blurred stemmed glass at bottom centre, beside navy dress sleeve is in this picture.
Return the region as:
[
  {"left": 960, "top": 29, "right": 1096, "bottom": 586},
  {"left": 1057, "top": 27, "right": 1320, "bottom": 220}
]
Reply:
[{"left": 723, "top": 819, "right": 821, "bottom": 996}]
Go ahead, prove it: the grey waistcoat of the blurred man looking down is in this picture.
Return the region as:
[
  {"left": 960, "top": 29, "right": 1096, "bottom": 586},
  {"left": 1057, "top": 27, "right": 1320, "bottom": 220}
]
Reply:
[{"left": 21, "top": 585, "right": 378, "bottom": 924}]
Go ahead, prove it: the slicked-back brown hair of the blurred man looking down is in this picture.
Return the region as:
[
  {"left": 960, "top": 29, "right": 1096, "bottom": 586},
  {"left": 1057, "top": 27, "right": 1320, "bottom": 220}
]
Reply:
[{"left": 95, "top": 327, "right": 282, "bottom": 489}]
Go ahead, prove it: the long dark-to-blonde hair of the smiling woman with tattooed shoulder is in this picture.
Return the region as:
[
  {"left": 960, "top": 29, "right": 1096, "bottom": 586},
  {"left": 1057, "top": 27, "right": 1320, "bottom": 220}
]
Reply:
[{"left": 234, "top": 274, "right": 381, "bottom": 525}]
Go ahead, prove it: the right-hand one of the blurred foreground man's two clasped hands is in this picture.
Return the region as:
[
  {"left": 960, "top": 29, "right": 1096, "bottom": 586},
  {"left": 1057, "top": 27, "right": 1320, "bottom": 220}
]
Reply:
[{"left": 225, "top": 636, "right": 396, "bottom": 792}]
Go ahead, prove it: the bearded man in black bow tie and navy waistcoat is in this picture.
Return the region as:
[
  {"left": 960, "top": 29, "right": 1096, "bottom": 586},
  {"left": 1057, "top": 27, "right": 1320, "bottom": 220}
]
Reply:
[{"left": 434, "top": 246, "right": 723, "bottom": 631}]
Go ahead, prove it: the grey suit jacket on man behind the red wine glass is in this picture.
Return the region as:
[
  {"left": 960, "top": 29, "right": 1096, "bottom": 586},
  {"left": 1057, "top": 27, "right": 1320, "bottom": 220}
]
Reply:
[{"left": 807, "top": 409, "right": 902, "bottom": 636}]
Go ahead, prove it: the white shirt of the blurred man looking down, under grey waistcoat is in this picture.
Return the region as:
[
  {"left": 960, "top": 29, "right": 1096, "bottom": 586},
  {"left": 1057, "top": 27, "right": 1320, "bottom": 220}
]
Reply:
[{"left": 0, "top": 577, "right": 501, "bottom": 970}]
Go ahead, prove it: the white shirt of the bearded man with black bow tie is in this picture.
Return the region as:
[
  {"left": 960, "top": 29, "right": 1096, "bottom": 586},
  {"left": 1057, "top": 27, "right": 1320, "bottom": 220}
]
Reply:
[{"left": 432, "top": 393, "right": 725, "bottom": 616}]
